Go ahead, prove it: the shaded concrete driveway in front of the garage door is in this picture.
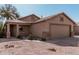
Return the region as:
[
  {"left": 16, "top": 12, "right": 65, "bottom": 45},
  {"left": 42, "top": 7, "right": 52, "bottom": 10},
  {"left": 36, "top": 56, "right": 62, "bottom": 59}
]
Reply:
[{"left": 47, "top": 36, "right": 79, "bottom": 47}]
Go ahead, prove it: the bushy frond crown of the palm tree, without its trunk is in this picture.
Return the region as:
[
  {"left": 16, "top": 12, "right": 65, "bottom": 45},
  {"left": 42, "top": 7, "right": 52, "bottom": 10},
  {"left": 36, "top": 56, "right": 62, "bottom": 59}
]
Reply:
[{"left": 0, "top": 4, "right": 19, "bottom": 20}]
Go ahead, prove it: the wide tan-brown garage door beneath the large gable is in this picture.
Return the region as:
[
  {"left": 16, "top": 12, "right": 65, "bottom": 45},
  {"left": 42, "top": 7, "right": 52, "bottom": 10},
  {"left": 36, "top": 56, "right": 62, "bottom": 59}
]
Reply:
[{"left": 50, "top": 24, "right": 70, "bottom": 38}]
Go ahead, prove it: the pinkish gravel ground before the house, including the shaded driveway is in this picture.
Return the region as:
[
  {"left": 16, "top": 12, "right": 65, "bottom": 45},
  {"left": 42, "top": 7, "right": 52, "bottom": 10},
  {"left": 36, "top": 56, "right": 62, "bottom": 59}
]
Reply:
[{"left": 0, "top": 38, "right": 79, "bottom": 55}]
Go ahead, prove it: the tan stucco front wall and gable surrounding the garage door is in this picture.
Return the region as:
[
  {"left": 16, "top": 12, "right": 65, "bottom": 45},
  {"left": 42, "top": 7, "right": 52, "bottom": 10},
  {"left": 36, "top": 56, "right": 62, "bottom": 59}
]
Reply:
[{"left": 31, "top": 15, "right": 74, "bottom": 37}]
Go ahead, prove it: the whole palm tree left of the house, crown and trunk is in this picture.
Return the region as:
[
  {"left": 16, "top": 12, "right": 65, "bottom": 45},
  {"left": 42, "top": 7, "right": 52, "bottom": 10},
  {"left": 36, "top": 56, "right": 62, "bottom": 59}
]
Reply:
[{"left": 0, "top": 4, "right": 20, "bottom": 37}]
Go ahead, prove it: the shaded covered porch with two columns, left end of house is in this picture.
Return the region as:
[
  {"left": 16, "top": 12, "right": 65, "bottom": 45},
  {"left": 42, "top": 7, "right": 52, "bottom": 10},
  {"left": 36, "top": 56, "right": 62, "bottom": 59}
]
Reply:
[{"left": 6, "top": 20, "right": 30, "bottom": 38}]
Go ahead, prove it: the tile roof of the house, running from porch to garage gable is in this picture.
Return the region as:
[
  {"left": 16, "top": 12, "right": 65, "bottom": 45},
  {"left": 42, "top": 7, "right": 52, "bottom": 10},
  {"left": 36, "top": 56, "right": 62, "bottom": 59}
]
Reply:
[{"left": 6, "top": 12, "right": 76, "bottom": 24}]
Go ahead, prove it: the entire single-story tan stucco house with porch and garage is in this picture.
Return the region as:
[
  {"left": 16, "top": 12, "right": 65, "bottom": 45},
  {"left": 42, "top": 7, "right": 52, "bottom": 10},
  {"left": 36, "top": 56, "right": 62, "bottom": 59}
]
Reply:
[{"left": 6, "top": 13, "right": 76, "bottom": 38}]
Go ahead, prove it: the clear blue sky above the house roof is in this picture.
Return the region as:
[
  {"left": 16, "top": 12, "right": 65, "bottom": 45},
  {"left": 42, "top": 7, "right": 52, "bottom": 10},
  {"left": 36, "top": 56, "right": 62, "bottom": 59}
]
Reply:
[{"left": 0, "top": 4, "right": 79, "bottom": 22}]
